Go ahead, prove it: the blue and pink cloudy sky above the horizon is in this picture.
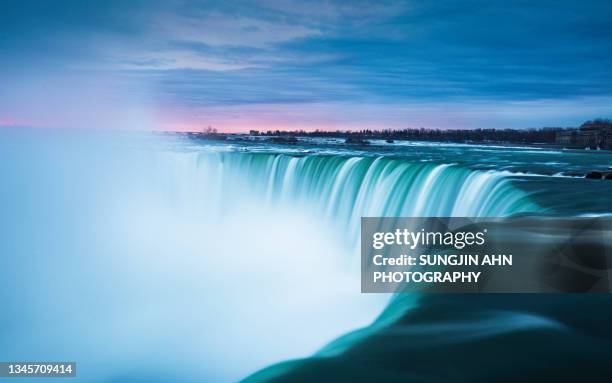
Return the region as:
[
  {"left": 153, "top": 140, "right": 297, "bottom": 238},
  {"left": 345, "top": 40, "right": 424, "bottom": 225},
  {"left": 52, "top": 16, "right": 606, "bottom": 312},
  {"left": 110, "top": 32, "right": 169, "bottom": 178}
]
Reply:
[{"left": 0, "top": 0, "right": 612, "bottom": 132}]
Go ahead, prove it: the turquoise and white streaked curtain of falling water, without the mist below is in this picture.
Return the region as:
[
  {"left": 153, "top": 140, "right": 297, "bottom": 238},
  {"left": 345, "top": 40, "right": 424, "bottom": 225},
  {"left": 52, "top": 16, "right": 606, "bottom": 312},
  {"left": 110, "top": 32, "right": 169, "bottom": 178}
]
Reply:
[{"left": 185, "top": 152, "right": 538, "bottom": 239}]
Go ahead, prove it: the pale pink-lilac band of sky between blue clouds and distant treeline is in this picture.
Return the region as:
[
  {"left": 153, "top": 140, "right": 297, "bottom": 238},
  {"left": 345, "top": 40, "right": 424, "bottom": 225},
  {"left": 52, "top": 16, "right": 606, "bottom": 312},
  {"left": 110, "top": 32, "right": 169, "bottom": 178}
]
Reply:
[{"left": 162, "top": 97, "right": 612, "bottom": 132}]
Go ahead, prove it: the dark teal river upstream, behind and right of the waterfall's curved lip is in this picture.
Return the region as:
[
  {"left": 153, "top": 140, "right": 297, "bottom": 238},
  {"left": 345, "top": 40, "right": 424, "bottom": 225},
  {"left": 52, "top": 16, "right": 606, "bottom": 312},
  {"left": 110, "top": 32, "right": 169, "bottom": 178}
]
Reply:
[{"left": 184, "top": 137, "right": 612, "bottom": 215}]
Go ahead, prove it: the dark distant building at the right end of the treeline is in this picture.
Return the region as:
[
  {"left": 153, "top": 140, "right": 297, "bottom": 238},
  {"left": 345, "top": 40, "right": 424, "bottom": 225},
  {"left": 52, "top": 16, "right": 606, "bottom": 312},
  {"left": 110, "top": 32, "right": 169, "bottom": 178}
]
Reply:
[{"left": 555, "top": 120, "right": 612, "bottom": 150}]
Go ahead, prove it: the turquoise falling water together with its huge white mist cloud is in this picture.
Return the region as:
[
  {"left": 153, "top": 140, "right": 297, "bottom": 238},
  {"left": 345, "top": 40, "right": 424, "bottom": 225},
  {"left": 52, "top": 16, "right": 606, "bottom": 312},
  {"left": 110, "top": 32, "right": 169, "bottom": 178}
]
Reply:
[{"left": 0, "top": 133, "right": 537, "bottom": 382}]
